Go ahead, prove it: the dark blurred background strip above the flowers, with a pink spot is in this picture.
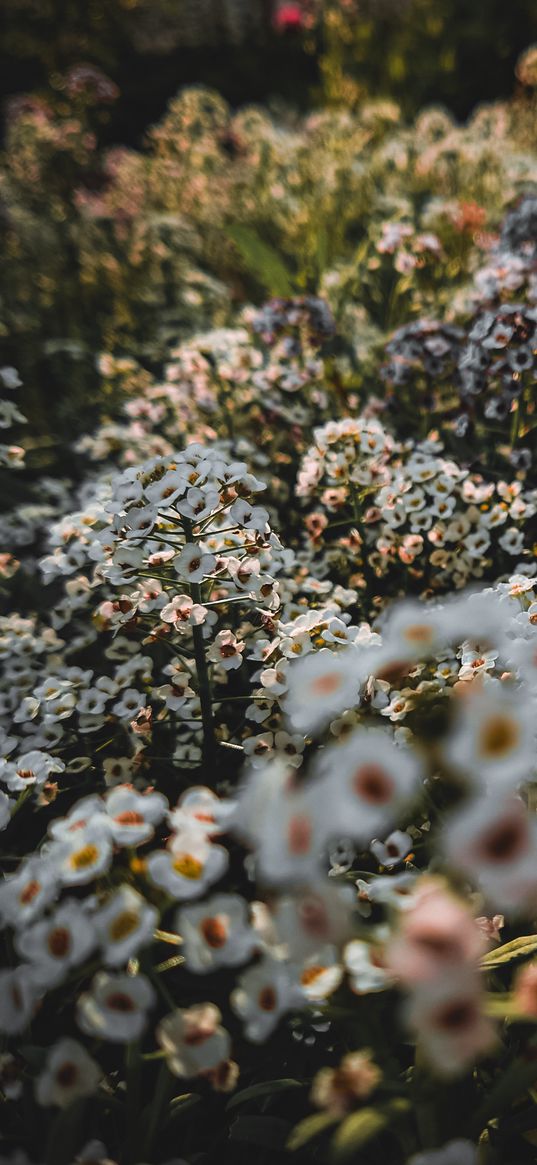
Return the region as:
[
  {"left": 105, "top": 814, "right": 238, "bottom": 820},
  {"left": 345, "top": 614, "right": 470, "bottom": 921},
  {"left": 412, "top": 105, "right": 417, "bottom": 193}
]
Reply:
[{"left": 0, "top": 0, "right": 537, "bottom": 131}]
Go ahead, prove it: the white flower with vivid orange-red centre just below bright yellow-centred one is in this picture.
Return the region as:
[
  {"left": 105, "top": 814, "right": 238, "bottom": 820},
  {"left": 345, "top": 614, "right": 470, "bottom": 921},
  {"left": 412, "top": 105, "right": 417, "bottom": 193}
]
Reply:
[{"left": 175, "top": 894, "right": 257, "bottom": 975}]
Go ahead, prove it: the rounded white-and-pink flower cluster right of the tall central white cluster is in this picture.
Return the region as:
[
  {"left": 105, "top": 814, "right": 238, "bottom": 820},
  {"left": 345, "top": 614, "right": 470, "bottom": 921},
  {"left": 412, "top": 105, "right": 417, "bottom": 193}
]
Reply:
[{"left": 297, "top": 418, "right": 536, "bottom": 600}]
